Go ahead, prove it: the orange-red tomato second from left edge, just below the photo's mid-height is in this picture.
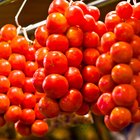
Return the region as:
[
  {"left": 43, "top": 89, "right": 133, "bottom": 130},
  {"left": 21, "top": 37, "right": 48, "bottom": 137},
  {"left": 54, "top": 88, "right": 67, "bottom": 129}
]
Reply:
[{"left": 8, "top": 70, "right": 25, "bottom": 88}]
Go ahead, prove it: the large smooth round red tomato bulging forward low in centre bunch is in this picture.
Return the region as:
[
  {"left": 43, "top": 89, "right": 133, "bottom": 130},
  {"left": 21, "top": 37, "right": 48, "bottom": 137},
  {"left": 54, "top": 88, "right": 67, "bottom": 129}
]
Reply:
[{"left": 42, "top": 74, "right": 69, "bottom": 99}]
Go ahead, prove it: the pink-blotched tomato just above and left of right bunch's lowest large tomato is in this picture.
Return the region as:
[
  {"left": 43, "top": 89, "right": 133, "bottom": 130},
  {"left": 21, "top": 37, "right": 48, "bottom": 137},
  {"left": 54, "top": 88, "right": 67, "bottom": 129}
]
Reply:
[{"left": 97, "top": 93, "right": 116, "bottom": 115}]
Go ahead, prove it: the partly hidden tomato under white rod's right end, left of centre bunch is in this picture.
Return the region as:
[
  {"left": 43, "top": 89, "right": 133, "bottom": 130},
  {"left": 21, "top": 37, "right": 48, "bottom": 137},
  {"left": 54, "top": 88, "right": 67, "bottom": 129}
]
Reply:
[{"left": 35, "top": 25, "right": 49, "bottom": 47}]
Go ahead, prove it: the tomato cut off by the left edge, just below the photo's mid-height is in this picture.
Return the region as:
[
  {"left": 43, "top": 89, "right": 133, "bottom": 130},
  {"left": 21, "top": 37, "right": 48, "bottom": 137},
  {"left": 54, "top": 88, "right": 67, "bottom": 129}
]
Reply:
[{"left": 0, "top": 75, "right": 10, "bottom": 93}]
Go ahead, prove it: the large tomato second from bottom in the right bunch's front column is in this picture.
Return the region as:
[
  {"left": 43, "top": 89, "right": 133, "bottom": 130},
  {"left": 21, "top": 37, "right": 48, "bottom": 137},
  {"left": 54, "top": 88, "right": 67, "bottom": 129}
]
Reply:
[{"left": 112, "top": 84, "right": 137, "bottom": 107}]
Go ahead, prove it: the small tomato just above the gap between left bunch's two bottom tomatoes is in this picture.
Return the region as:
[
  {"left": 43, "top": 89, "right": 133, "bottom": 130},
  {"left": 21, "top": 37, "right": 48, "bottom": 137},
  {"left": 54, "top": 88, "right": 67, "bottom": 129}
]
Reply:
[{"left": 20, "top": 108, "right": 35, "bottom": 125}]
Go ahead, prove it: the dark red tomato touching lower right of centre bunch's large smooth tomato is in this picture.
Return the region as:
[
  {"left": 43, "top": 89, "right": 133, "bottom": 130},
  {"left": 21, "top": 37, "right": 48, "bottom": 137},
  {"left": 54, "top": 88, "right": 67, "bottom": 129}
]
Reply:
[{"left": 59, "top": 89, "right": 83, "bottom": 113}]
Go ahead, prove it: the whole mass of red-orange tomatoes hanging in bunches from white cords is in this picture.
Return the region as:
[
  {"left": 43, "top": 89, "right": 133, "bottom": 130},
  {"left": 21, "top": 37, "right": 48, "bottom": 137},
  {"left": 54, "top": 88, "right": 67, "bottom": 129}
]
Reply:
[{"left": 0, "top": 0, "right": 140, "bottom": 136}]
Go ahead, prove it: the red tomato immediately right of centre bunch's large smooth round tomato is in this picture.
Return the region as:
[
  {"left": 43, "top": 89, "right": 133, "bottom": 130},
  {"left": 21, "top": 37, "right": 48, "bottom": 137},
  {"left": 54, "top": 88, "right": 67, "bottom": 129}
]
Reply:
[{"left": 64, "top": 67, "right": 83, "bottom": 89}]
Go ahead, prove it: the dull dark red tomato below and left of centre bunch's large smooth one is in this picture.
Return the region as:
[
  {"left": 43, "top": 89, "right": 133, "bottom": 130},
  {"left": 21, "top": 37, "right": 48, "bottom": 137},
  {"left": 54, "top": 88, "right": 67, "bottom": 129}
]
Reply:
[{"left": 38, "top": 97, "right": 60, "bottom": 118}]
